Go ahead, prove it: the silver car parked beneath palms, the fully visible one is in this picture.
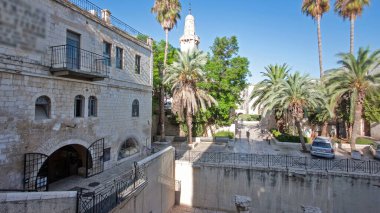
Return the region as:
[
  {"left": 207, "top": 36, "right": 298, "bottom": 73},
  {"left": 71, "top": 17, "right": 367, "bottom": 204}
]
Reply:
[{"left": 310, "top": 136, "right": 335, "bottom": 158}]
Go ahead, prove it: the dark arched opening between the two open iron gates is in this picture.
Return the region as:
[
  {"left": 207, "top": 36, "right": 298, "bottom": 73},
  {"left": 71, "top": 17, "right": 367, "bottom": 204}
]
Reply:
[{"left": 38, "top": 144, "right": 92, "bottom": 184}]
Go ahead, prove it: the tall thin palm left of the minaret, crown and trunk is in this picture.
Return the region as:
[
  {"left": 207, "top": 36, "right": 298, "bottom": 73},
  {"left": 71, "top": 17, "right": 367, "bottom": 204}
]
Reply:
[{"left": 152, "top": 0, "right": 181, "bottom": 141}]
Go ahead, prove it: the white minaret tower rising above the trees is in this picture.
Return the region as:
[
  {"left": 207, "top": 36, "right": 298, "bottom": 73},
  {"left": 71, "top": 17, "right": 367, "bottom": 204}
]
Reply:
[{"left": 179, "top": 8, "right": 200, "bottom": 52}]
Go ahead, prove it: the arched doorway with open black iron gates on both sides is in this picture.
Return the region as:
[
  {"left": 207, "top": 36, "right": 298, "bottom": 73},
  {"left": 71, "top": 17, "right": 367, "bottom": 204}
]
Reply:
[{"left": 24, "top": 138, "right": 104, "bottom": 191}]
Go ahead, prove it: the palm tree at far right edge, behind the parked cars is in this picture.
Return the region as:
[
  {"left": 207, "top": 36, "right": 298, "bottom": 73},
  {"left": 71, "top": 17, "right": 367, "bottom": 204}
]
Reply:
[{"left": 326, "top": 48, "right": 380, "bottom": 150}]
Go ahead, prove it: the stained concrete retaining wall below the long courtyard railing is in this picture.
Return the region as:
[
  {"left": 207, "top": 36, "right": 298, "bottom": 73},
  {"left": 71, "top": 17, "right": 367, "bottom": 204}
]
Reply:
[{"left": 176, "top": 161, "right": 380, "bottom": 213}]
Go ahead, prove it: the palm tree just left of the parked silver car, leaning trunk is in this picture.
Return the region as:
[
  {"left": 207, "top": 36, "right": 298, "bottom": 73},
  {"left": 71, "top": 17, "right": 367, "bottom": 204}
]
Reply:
[{"left": 261, "top": 72, "right": 324, "bottom": 151}]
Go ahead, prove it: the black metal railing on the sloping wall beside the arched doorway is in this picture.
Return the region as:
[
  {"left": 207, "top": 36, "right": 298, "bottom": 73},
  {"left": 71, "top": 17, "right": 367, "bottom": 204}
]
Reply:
[{"left": 77, "top": 164, "right": 147, "bottom": 213}]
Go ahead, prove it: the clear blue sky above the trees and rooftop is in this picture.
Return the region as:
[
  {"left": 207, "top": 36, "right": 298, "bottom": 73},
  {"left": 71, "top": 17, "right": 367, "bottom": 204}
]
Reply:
[{"left": 90, "top": 0, "right": 380, "bottom": 82}]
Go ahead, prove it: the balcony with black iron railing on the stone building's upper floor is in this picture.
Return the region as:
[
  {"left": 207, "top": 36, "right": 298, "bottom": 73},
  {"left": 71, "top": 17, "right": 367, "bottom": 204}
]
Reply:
[{"left": 50, "top": 45, "right": 109, "bottom": 81}]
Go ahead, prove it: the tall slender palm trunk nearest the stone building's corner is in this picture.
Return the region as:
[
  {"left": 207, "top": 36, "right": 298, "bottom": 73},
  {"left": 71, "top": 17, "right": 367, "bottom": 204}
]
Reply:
[{"left": 160, "top": 29, "right": 169, "bottom": 141}]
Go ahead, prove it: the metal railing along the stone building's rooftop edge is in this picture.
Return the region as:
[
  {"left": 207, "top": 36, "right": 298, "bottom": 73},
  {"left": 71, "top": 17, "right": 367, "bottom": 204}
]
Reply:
[{"left": 67, "top": 0, "right": 146, "bottom": 42}]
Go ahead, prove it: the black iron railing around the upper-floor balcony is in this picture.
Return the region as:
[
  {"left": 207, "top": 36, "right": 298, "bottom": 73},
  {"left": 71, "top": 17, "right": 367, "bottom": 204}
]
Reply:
[{"left": 51, "top": 45, "right": 110, "bottom": 76}]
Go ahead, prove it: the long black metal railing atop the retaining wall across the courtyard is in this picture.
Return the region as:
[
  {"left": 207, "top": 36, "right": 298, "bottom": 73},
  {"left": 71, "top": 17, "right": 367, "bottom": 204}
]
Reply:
[{"left": 176, "top": 150, "right": 380, "bottom": 176}]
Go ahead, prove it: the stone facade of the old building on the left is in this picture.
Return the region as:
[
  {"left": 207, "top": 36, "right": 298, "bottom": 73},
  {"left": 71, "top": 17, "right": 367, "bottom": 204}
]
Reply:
[{"left": 0, "top": 0, "right": 152, "bottom": 189}]
